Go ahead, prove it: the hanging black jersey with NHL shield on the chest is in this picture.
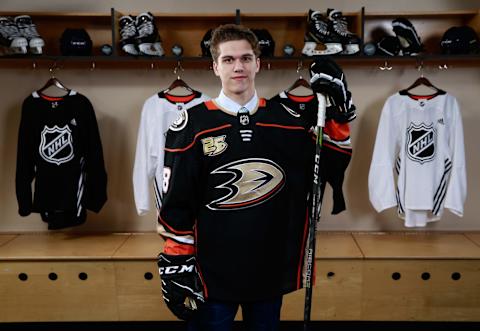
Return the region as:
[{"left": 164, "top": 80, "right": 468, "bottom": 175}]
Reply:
[{"left": 16, "top": 91, "right": 107, "bottom": 229}]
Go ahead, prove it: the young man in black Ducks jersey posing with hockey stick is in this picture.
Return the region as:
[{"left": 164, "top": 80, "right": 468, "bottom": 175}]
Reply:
[{"left": 158, "top": 25, "right": 314, "bottom": 331}]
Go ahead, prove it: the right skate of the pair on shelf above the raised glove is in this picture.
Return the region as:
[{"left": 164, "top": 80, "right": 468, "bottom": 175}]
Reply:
[{"left": 327, "top": 8, "right": 361, "bottom": 55}]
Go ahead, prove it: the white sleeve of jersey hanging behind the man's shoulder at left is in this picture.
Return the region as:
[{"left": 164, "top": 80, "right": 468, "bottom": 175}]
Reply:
[{"left": 133, "top": 96, "right": 160, "bottom": 215}]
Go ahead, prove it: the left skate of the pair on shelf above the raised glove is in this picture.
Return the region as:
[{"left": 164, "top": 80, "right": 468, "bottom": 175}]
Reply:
[{"left": 302, "top": 9, "right": 343, "bottom": 56}]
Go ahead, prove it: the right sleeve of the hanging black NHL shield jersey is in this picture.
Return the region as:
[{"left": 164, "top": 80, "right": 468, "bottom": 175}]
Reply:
[{"left": 83, "top": 97, "right": 107, "bottom": 213}]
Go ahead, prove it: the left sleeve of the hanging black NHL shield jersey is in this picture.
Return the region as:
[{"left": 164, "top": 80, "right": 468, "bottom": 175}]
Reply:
[{"left": 15, "top": 98, "right": 35, "bottom": 216}]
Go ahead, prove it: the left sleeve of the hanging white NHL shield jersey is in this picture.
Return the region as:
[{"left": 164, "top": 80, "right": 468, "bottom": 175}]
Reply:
[{"left": 368, "top": 98, "right": 397, "bottom": 212}]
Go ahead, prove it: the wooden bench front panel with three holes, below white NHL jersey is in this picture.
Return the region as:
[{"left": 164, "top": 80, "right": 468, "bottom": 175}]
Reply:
[{"left": 361, "top": 260, "right": 480, "bottom": 321}]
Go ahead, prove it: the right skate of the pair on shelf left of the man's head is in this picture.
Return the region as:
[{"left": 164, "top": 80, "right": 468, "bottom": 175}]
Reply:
[{"left": 135, "top": 13, "right": 165, "bottom": 56}]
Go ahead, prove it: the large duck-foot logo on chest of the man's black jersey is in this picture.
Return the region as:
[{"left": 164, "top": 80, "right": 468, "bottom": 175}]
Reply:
[{"left": 207, "top": 158, "right": 285, "bottom": 210}]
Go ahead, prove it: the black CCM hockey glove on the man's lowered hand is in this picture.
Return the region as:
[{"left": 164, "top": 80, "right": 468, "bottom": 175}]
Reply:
[{"left": 158, "top": 253, "right": 205, "bottom": 321}]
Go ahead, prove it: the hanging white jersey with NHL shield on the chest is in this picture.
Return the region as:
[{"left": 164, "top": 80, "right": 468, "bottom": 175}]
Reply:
[{"left": 368, "top": 93, "right": 467, "bottom": 227}]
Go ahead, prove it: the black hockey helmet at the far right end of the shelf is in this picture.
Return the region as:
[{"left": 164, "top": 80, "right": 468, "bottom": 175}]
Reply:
[{"left": 440, "top": 25, "right": 480, "bottom": 54}]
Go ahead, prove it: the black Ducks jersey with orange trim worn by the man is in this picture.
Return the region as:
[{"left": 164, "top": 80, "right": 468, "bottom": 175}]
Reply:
[{"left": 158, "top": 99, "right": 314, "bottom": 302}]
